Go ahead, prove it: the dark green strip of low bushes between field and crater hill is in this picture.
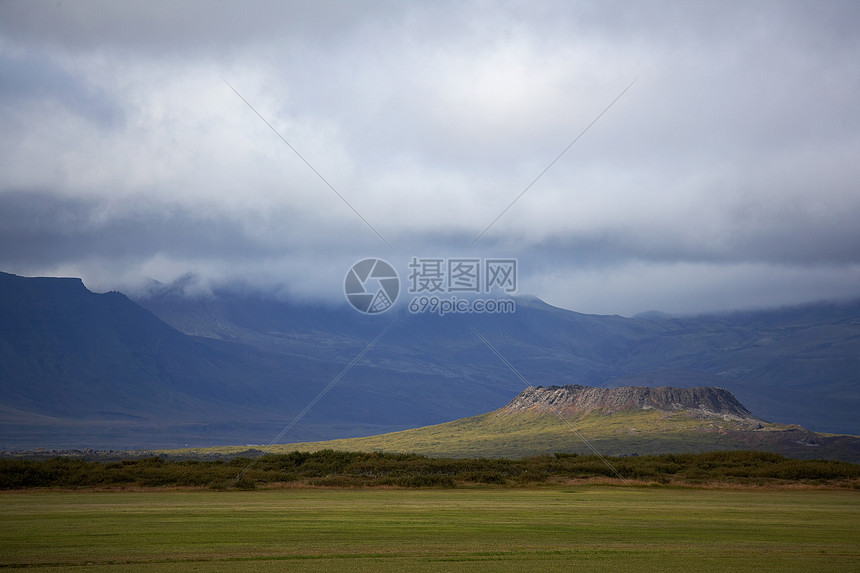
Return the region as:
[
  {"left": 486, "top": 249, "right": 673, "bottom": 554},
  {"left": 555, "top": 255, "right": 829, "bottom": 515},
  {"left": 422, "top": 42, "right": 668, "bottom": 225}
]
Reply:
[{"left": 0, "top": 450, "right": 860, "bottom": 490}]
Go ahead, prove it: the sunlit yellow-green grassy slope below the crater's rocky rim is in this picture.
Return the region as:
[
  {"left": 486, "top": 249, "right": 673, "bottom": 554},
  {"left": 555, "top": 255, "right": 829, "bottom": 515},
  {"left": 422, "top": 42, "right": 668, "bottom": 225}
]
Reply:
[{"left": 180, "top": 409, "right": 860, "bottom": 462}]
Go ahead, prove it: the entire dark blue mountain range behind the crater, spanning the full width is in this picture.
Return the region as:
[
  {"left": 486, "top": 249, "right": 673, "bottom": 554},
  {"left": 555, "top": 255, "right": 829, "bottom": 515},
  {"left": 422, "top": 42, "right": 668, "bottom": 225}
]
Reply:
[{"left": 0, "top": 273, "right": 860, "bottom": 449}]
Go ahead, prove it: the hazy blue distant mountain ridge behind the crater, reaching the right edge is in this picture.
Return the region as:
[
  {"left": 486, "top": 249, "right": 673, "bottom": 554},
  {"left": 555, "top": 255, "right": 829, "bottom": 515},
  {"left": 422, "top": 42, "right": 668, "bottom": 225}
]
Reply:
[{"left": 137, "top": 287, "right": 860, "bottom": 434}]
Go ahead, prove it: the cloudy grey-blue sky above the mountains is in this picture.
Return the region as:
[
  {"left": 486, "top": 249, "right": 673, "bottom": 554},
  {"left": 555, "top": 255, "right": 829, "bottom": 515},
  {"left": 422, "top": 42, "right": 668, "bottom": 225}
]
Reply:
[{"left": 0, "top": 0, "right": 860, "bottom": 316}]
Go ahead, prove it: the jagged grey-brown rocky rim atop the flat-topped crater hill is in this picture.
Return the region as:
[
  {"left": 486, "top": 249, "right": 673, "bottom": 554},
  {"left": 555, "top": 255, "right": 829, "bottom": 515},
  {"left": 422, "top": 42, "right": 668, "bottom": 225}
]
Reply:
[{"left": 504, "top": 384, "right": 760, "bottom": 421}]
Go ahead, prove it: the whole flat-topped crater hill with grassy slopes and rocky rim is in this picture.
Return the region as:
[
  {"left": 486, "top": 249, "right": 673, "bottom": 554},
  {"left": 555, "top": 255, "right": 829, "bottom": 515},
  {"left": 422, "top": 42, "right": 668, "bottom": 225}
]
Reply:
[{"left": 255, "top": 385, "right": 860, "bottom": 463}]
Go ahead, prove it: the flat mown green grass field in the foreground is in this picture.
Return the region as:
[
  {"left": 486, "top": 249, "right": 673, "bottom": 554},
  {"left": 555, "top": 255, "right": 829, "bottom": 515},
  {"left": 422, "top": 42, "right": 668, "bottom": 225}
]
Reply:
[{"left": 0, "top": 485, "right": 860, "bottom": 573}]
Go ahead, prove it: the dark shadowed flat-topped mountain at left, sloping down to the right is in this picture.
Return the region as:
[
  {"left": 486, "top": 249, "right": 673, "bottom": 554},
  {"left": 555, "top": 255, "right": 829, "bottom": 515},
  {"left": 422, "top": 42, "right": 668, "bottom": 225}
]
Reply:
[{"left": 0, "top": 274, "right": 346, "bottom": 445}]
